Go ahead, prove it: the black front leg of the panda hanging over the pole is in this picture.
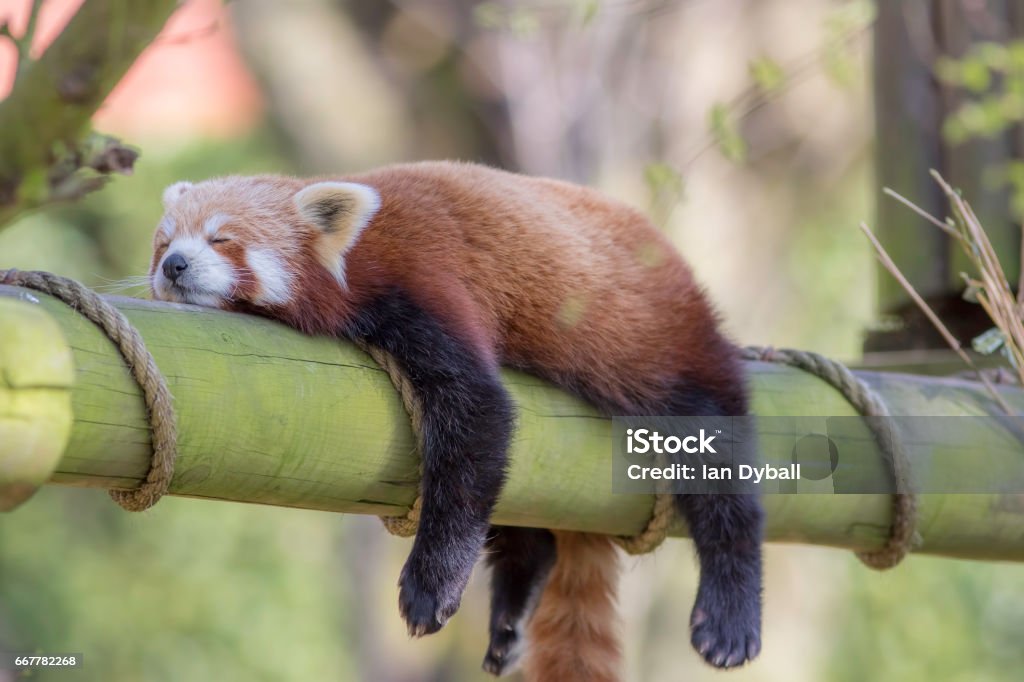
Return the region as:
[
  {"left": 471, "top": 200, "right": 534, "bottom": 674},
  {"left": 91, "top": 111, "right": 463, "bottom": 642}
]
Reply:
[{"left": 344, "top": 293, "right": 513, "bottom": 637}]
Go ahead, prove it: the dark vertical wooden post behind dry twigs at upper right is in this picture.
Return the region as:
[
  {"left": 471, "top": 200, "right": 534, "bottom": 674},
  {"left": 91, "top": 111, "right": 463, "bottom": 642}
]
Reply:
[{"left": 864, "top": 0, "right": 1024, "bottom": 364}]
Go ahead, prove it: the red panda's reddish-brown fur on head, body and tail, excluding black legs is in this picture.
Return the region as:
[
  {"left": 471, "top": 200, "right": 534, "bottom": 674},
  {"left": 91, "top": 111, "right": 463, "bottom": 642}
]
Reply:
[{"left": 153, "top": 162, "right": 741, "bottom": 682}]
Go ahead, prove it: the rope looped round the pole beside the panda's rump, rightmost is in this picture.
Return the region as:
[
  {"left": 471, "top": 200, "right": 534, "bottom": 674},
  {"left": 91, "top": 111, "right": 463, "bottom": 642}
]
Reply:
[{"left": 742, "top": 346, "right": 918, "bottom": 570}]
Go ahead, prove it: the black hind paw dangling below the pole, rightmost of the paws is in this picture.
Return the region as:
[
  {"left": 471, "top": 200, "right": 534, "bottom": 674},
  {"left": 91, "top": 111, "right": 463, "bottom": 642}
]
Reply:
[{"left": 690, "top": 590, "right": 761, "bottom": 668}]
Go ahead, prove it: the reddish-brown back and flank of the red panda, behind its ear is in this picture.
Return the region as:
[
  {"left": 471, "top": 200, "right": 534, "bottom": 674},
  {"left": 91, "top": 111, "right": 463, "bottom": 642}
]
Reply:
[{"left": 347, "top": 162, "right": 730, "bottom": 411}]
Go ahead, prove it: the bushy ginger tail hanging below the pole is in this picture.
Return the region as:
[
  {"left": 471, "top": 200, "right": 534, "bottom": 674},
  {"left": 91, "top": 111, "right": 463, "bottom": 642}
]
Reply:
[{"left": 523, "top": 531, "right": 623, "bottom": 682}]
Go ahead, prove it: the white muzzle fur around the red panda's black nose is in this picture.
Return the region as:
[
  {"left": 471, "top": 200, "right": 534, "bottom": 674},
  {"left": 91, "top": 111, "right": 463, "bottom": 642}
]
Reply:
[{"left": 153, "top": 237, "right": 234, "bottom": 307}]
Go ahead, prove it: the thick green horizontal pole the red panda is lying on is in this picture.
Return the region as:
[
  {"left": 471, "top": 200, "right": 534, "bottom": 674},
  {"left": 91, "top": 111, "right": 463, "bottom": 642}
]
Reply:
[{"left": 0, "top": 287, "right": 1024, "bottom": 560}]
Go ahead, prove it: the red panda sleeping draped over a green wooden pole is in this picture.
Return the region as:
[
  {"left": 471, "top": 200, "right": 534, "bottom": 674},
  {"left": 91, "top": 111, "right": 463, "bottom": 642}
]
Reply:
[{"left": 150, "top": 162, "right": 763, "bottom": 682}]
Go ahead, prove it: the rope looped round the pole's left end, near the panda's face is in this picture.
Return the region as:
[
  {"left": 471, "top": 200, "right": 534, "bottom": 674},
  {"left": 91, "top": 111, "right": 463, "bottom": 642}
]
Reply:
[{"left": 0, "top": 269, "right": 177, "bottom": 511}]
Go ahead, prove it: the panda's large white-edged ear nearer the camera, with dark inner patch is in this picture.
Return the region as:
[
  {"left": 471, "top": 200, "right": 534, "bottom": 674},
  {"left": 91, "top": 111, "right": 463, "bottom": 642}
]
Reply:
[{"left": 295, "top": 182, "right": 381, "bottom": 285}]
